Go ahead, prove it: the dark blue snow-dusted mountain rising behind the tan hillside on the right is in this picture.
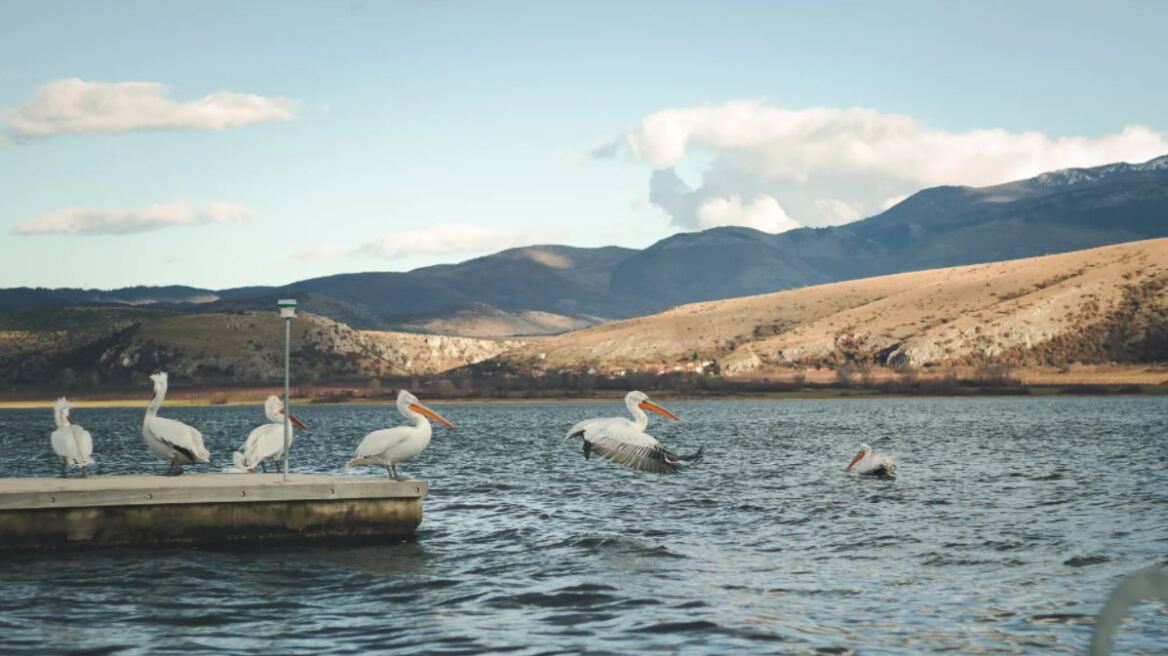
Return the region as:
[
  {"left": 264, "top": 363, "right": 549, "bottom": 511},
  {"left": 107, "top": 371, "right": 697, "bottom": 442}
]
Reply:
[{"left": 613, "top": 156, "right": 1168, "bottom": 307}]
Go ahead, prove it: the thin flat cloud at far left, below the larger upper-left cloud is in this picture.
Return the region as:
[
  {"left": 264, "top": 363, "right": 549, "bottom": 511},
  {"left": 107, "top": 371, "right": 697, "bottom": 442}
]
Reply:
[{"left": 12, "top": 202, "right": 251, "bottom": 235}]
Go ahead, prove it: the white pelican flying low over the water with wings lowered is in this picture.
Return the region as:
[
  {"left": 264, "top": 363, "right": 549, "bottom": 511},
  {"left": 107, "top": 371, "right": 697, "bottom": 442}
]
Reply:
[{"left": 564, "top": 391, "right": 704, "bottom": 474}]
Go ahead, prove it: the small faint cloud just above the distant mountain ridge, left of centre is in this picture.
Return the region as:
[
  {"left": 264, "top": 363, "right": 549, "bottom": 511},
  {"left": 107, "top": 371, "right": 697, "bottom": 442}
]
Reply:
[{"left": 352, "top": 223, "right": 540, "bottom": 259}]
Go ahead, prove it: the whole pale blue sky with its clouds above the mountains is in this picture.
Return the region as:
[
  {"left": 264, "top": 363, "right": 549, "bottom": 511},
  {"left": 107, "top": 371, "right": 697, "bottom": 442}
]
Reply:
[{"left": 0, "top": 1, "right": 1168, "bottom": 288}]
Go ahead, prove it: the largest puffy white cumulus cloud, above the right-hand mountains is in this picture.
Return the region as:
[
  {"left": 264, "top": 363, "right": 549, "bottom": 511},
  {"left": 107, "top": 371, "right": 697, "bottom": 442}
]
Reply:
[{"left": 591, "top": 102, "right": 1168, "bottom": 228}]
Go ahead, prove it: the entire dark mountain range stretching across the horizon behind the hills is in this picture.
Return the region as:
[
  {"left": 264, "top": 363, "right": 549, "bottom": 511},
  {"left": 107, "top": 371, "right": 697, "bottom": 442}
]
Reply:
[{"left": 0, "top": 155, "right": 1168, "bottom": 337}]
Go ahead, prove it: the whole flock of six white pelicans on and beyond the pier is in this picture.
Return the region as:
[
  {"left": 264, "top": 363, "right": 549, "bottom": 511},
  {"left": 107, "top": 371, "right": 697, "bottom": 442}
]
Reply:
[{"left": 50, "top": 372, "right": 896, "bottom": 480}]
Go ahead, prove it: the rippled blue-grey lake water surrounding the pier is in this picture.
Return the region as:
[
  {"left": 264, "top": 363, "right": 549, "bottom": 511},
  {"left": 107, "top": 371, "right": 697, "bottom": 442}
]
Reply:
[{"left": 0, "top": 397, "right": 1168, "bottom": 654}]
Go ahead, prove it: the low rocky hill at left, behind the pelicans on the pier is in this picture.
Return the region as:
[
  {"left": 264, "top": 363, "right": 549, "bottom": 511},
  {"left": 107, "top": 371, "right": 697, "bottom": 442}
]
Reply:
[{"left": 0, "top": 310, "right": 523, "bottom": 384}]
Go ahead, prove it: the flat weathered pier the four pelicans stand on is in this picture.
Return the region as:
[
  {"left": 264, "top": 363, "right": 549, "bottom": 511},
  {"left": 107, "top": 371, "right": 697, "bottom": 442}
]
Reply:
[{"left": 0, "top": 474, "right": 429, "bottom": 552}]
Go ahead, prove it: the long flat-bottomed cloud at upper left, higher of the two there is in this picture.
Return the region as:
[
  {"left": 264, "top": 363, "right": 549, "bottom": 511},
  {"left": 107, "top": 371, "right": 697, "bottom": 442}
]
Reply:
[{"left": 7, "top": 78, "right": 296, "bottom": 137}]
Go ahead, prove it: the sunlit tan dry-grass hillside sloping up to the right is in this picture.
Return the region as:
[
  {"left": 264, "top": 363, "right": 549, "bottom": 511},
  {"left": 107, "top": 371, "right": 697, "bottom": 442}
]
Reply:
[{"left": 501, "top": 239, "right": 1168, "bottom": 375}]
